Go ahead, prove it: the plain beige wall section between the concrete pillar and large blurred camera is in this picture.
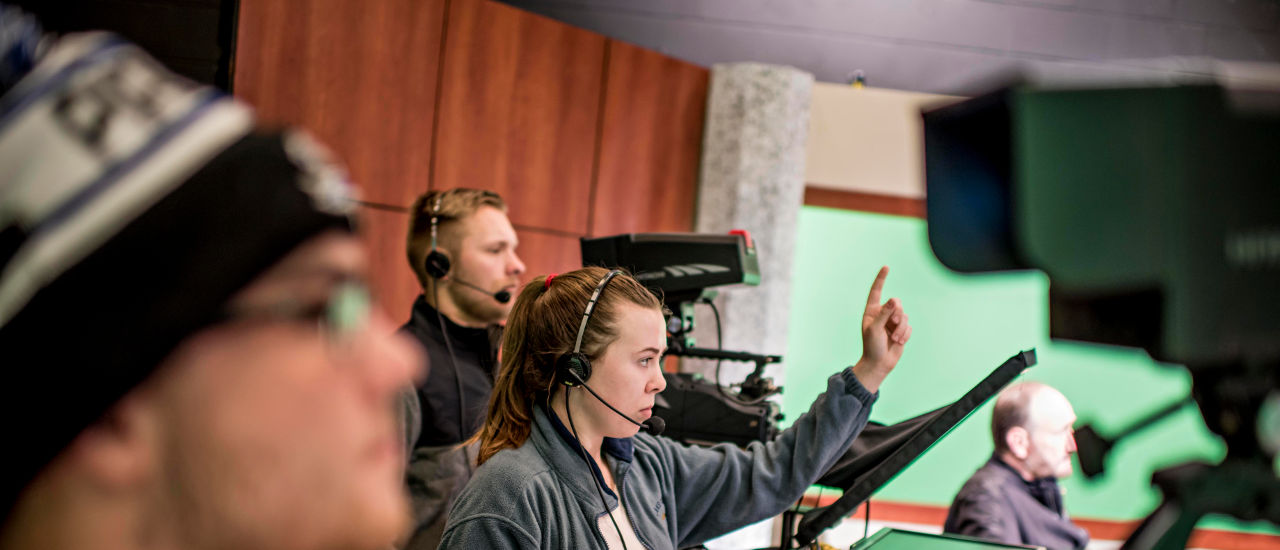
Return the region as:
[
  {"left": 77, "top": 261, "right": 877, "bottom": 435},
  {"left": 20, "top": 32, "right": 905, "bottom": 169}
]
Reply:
[{"left": 805, "top": 83, "right": 960, "bottom": 198}]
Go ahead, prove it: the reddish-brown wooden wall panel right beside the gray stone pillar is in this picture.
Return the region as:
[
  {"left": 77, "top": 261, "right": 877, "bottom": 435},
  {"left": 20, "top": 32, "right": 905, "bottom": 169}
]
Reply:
[{"left": 590, "top": 40, "right": 710, "bottom": 237}]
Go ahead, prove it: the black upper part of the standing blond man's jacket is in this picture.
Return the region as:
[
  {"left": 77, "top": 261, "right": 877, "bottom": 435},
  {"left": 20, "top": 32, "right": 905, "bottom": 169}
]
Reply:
[{"left": 401, "top": 295, "right": 502, "bottom": 448}]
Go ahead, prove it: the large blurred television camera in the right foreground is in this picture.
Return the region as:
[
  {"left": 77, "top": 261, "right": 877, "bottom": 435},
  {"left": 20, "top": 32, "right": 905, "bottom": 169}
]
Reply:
[{"left": 924, "top": 84, "right": 1280, "bottom": 549}]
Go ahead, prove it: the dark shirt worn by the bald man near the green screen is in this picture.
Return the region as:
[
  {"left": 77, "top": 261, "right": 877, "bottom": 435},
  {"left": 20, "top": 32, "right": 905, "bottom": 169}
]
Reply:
[{"left": 943, "top": 457, "right": 1089, "bottom": 549}]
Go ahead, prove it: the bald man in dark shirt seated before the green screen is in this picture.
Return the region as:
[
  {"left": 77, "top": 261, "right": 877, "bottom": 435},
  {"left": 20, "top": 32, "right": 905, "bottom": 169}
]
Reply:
[{"left": 943, "top": 382, "right": 1089, "bottom": 549}]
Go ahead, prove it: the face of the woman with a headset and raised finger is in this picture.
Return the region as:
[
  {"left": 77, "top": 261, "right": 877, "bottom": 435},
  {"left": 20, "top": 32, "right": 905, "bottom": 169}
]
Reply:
[{"left": 572, "top": 303, "right": 667, "bottom": 439}]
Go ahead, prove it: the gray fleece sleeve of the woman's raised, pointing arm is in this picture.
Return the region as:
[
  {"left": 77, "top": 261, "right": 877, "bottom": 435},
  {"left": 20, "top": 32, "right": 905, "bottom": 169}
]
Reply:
[{"left": 657, "top": 368, "right": 877, "bottom": 547}]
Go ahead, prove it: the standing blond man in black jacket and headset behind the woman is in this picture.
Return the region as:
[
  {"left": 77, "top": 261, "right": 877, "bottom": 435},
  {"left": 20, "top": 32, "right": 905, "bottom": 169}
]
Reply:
[{"left": 401, "top": 188, "right": 525, "bottom": 549}]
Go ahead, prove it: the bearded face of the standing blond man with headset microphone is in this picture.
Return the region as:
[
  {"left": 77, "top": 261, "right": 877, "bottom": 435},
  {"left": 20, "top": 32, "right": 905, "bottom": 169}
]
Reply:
[{"left": 440, "top": 206, "right": 525, "bottom": 326}]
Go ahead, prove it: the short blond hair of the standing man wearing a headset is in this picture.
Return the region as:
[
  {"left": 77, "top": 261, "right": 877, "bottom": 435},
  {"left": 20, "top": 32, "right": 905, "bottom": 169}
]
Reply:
[{"left": 406, "top": 188, "right": 507, "bottom": 288}]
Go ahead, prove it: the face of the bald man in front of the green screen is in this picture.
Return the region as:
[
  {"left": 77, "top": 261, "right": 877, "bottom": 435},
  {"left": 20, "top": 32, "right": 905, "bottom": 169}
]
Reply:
[{"left": 1024, "top": 389, "right": 1075, "bottom": 478}]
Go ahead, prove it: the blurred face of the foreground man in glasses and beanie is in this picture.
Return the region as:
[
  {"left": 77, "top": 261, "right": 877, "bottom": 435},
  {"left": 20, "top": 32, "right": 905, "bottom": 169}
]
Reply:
[{"left": 145, "top": 233, "right": 422, "bottom": 549}]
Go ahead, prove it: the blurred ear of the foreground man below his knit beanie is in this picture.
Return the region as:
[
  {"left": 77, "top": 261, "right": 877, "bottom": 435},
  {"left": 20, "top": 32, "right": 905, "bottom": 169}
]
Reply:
[{"left": 67, "top": 390, "right": 159, "bottom": 489}]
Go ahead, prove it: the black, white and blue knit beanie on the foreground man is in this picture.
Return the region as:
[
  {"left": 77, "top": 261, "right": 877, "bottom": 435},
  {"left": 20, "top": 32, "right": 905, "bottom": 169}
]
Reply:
[{"left": 0, "top": 11, "right": 352, "bottom": 518}]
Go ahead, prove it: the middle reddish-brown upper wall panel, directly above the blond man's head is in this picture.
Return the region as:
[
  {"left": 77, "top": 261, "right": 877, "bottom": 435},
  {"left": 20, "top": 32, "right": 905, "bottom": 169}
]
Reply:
[{"left": 433, "top": 0, "right": 604, "bottom": 234}]
